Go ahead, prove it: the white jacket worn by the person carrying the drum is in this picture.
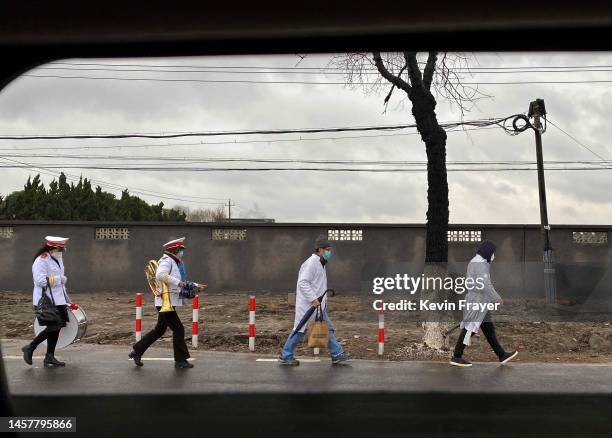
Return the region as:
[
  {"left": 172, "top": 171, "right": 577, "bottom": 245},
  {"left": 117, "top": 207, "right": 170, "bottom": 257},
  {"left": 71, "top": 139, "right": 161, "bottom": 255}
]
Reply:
[{"left": 32, "top": 252, "right": 71, "bottom": 306}]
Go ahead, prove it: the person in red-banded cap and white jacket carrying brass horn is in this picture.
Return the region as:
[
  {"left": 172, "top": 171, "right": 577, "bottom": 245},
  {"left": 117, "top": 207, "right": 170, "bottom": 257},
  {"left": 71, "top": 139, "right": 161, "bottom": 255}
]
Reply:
[{"left": 129, "top": 237, "right": 204, "bottom": 368}]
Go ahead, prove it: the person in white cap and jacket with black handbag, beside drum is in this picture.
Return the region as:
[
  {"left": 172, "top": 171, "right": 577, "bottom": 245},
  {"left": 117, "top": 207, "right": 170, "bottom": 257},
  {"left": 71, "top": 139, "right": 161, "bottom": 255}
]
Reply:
[{"left": 21, "top": 236, "right": 77, "bottom": 367}]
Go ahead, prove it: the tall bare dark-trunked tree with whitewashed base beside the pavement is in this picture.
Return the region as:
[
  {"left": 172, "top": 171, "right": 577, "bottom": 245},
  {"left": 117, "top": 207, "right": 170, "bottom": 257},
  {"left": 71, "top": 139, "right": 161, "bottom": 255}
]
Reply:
[{"left": 331, "top": 52, "right": 486, "bottom": 350}]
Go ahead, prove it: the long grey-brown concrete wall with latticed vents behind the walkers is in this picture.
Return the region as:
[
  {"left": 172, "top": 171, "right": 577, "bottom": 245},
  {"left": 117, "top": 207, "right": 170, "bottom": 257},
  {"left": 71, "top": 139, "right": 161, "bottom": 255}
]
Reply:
[{"left": 0, "top": 221, "right": 612, "bottom": 299}]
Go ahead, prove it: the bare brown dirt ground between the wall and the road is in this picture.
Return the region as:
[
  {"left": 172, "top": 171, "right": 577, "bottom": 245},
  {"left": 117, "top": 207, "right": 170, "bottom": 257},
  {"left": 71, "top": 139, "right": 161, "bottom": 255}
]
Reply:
[{"left": 0, "top": 292, "right": 612, "bottom": 363}]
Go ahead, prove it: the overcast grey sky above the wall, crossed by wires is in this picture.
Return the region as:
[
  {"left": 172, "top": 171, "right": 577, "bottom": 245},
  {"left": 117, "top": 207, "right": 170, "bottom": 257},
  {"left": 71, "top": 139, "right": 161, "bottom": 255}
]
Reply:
[{"left": 0, "top": 53, "right": 612, "bottom": 224}]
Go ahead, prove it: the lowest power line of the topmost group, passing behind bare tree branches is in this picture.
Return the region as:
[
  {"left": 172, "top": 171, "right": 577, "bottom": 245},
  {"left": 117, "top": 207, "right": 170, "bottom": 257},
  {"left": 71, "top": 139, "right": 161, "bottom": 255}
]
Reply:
[{"left": 20, "top": 74, "right": 612, "bottom": 85}]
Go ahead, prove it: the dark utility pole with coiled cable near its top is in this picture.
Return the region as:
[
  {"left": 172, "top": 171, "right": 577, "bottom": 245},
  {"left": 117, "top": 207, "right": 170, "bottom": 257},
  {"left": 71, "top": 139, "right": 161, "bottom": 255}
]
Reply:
[{"left": 528, "top": 99, "right": 557, "bottom": 304}]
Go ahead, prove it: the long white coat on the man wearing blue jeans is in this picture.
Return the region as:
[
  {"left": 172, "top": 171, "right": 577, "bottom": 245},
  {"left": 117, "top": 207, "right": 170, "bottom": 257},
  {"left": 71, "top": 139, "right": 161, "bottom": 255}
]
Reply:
[{"left": 293, "top": 254, "right": 327, "bottom": 332}]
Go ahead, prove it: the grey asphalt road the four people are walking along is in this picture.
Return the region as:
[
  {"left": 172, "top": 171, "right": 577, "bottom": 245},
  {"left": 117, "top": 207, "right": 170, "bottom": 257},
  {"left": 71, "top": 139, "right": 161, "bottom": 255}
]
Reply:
[{"left": 2, "top": 340, "right": 612, "bottom": 395}]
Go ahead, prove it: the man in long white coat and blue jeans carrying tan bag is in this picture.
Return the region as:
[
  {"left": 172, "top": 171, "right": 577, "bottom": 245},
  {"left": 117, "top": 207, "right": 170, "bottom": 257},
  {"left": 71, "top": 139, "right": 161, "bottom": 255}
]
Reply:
[{"left": 278, "top": 236, "right": 351, "bottom": 366}]
